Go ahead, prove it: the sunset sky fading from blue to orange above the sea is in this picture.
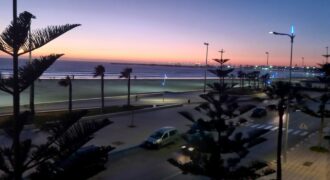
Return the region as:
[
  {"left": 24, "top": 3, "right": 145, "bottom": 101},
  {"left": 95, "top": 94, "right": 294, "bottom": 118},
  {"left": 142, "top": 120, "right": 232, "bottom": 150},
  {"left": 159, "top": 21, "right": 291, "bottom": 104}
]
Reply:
[{"left": 0, "top": 0, "right": 330, "bottom": 65}]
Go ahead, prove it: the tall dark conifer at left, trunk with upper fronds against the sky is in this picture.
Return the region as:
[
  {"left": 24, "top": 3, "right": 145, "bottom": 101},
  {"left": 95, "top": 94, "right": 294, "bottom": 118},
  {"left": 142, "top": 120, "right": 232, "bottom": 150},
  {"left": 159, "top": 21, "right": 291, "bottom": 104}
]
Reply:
[{"left": 0, "top": 7, "right": 79, "bottom": 179}]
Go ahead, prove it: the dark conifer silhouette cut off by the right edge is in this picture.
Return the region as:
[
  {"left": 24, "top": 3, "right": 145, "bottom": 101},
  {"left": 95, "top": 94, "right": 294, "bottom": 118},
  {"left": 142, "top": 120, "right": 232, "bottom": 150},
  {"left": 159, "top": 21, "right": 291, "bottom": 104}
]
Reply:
[{"left": 300, "top": 63, "right": 330, "bottom": 147}]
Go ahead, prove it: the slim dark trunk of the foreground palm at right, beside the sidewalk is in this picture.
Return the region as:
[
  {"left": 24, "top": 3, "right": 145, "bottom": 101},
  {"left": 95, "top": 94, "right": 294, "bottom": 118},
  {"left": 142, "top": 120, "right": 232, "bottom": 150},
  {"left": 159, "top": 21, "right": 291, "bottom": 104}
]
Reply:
[{"left": 276, "top": 105, "right": 284, "bottom": 180}]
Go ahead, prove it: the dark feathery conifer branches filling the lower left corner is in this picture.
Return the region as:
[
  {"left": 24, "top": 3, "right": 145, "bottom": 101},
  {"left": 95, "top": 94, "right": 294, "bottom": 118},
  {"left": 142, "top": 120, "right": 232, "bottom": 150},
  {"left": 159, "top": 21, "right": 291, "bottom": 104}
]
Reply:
[{"left": 0, "top": 111, "right": 114, "bottom": 180}]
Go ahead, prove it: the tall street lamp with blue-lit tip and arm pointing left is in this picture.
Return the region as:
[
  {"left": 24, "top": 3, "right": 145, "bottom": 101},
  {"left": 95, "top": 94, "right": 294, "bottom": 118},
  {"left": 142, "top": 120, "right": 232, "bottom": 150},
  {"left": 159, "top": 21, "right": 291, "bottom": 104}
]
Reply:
[{"left": 269, "top": 26, "right": 295, "bottom": 167}]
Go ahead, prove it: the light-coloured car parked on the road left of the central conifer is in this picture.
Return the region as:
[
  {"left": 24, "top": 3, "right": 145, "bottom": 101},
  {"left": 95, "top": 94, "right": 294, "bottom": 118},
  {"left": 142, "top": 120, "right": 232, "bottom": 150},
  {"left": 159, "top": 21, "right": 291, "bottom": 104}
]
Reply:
[{"left": 144, "top": 127, "right": 179, "bottom": 148}]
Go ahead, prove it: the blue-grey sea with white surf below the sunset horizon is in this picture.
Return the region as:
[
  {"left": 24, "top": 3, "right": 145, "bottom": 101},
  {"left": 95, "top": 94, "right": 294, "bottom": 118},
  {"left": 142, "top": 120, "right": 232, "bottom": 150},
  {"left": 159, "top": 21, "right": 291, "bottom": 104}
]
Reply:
[{"left": 0, "top": 58, "right": 319, "bottom": 79}]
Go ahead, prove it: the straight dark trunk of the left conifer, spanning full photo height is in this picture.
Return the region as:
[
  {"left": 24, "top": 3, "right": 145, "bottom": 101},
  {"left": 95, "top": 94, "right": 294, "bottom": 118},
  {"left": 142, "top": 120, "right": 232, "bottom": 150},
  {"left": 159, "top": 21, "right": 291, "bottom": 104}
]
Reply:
[{"left": 13, "top": 0, "right": 22, "bottom": 180}]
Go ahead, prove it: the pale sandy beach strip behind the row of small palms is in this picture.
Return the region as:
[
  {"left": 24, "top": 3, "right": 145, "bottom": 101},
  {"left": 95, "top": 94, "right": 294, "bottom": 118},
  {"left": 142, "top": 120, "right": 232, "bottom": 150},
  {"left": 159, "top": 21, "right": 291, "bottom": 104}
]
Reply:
[{"left": 0, "top": 79, "right": 220, "bottom": 107}]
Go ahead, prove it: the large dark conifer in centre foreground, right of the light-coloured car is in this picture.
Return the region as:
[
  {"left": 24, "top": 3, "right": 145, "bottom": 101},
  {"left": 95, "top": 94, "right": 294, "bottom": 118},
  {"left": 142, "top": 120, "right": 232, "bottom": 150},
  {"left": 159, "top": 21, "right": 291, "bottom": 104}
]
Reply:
[{"left": 169, "top": 60, "right": 267, "bottom": 179}]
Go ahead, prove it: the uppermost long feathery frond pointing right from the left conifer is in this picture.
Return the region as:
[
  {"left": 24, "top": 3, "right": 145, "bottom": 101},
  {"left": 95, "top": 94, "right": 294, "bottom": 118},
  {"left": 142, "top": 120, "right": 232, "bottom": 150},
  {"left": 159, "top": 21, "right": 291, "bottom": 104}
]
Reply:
[{"left": 19, "top": 24, "right": 80, "bottom": 55}]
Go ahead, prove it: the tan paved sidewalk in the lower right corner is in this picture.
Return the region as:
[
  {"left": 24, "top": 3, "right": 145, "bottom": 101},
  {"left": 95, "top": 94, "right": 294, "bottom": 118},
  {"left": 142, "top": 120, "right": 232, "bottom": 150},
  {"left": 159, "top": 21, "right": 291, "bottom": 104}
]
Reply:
[{"left": 261, "top": 123, "right": 330, "bottom": 180}]
